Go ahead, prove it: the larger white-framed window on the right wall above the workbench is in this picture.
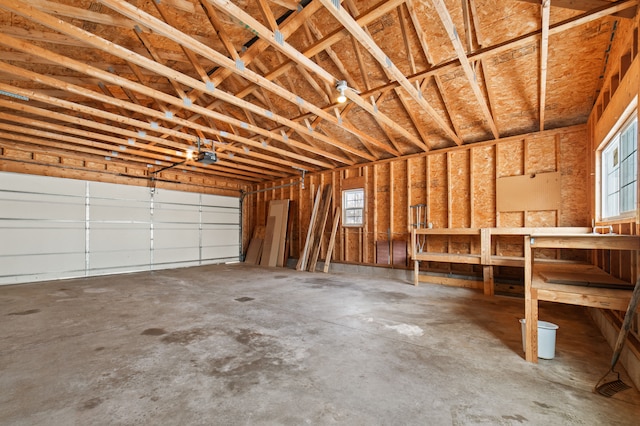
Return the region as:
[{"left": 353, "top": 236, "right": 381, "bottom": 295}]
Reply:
[{"left": 600, "top": 111, "right": 638, "bottom": 219}]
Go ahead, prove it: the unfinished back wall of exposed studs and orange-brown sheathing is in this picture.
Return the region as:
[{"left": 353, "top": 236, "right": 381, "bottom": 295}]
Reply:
[{"left": 246, "top": 125, "right": 591, "bottom": 272}]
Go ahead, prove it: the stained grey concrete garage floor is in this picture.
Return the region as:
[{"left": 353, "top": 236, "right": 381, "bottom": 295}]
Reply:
[{"left": 0, "top": 264, "right": 640, "bottom": 425}]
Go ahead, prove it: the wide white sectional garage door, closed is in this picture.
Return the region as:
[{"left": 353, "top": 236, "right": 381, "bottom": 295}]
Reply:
[{"left": 0, "top": 172, "right": 240, "bottom": 284}]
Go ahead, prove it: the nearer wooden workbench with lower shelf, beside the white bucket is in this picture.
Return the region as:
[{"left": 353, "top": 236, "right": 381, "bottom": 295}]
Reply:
[{"left": 524, "top": 233, "right": 640, "bottom": 362}]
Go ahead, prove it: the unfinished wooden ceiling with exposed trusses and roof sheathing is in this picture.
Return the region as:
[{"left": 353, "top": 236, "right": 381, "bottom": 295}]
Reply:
[{"left": 0, "top": 0, "right": 638, "bottom": 187}]
